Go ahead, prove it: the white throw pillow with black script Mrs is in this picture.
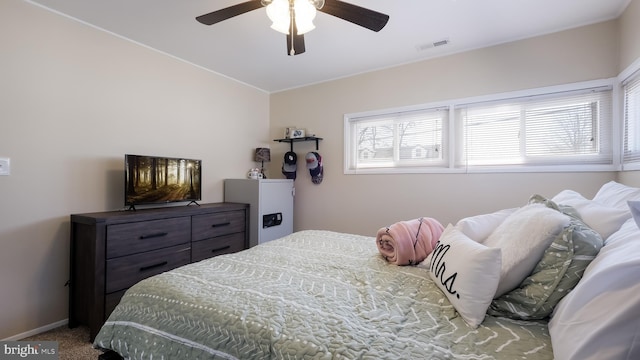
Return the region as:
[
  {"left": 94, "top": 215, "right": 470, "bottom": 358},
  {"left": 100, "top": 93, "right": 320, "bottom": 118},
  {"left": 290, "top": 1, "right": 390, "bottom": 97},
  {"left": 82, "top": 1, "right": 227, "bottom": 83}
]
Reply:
[{"left": 419, "top": 224, "right": 500, "bottom": 329}]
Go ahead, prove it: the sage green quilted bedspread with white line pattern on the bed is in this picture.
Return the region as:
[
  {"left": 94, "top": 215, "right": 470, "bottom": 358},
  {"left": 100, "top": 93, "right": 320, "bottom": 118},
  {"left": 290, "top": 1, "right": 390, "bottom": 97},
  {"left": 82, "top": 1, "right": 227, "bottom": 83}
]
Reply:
[{"left": 94, "top": 231, "right": 553, "bottom": 360}]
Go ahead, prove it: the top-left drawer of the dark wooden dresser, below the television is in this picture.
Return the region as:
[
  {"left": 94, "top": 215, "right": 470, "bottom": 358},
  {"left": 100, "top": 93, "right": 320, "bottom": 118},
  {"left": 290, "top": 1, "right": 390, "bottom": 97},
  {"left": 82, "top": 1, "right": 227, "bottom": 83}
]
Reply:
[{"left": 107, "top": 216, "right": 191, "bottom": 259}]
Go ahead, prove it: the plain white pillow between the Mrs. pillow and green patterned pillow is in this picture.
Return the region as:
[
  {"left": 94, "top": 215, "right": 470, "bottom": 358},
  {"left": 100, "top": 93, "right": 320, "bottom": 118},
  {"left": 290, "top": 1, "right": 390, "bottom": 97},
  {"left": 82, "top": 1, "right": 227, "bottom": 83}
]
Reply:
[{"left": 484, "top": 204, "right": 569, "bottom": 298}]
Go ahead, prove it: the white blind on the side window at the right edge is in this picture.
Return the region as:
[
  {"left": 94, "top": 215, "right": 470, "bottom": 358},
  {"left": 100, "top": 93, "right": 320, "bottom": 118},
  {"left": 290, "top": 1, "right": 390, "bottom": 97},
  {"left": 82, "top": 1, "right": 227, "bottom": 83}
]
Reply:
[{"left": 622, "top": 71, "right": 640, "bottom": 164}]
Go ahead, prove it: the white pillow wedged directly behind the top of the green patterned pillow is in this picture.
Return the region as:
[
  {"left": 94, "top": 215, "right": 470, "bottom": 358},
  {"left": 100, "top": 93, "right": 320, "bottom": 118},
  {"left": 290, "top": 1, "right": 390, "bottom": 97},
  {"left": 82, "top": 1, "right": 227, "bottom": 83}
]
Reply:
[{"left": 551, "top": 190, "right": 631, "bottom": 239}]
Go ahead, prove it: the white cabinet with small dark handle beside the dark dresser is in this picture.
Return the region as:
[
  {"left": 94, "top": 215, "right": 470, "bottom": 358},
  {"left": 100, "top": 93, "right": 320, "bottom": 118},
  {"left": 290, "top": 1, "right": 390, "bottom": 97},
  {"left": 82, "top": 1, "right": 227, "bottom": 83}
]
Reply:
[{"left": 224, "top": 179, "right": 295, "bottom": 246}]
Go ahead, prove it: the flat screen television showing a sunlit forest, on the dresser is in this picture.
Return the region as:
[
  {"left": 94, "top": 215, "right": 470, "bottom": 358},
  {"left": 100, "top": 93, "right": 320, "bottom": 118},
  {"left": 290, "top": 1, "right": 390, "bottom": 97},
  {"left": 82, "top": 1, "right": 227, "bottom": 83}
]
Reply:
[{"left": 124, "top": 154, "right": 202, "bottom": 210}]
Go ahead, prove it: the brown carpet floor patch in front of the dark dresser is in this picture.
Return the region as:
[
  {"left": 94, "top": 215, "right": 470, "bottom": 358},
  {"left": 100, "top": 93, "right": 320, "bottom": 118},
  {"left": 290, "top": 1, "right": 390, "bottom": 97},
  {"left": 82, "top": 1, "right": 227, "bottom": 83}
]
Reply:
[{"left": 21, "top": 325, "right": 102, "bottom": 360}]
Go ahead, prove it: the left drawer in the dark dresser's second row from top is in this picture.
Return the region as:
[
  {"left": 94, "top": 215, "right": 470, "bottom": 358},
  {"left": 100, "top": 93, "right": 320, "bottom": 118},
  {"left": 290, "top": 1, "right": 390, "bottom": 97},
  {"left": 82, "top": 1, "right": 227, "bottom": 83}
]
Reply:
[{"left": 106, "top": 245, "right": 191, "bottom": 293}]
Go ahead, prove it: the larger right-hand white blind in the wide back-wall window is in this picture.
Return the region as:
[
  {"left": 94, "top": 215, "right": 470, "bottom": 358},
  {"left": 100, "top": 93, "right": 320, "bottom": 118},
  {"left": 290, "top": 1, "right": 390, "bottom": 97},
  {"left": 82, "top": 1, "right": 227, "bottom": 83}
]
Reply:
[{"left": 456, "top": 86, "right": 613, "bottom": 167}]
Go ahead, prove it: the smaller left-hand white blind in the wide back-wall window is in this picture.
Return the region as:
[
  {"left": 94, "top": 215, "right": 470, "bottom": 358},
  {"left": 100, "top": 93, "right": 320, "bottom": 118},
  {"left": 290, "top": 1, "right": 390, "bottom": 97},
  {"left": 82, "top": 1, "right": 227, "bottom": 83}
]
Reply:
[{"left": 345, "top": 107, "right": 449, "bottom": 172}]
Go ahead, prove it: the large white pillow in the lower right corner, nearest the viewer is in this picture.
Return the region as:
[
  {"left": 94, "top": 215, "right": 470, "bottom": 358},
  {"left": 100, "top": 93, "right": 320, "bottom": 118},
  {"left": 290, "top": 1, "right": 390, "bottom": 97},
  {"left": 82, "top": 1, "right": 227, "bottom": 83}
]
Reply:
[{"left": 549, "top": 219, "right": 640, "bottom": 360}]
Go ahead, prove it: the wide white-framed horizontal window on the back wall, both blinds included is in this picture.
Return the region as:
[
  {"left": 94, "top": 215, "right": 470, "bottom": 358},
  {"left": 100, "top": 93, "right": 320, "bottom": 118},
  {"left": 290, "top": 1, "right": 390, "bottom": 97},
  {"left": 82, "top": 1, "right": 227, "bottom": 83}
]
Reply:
[{"left": 345, "top": 79, "right": 616, "bottom": 174}]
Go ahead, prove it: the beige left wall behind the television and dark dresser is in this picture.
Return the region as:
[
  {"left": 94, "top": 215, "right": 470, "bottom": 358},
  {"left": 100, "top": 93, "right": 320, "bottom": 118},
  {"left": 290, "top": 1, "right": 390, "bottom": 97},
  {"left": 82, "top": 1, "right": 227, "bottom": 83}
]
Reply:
[{"left": 0, "top": 0, "right": 272, "bottom": 339}]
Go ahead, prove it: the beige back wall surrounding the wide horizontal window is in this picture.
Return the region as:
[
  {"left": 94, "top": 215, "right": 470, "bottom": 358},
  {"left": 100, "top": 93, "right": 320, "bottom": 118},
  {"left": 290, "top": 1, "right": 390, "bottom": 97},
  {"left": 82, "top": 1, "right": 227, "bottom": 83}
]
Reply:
[{"left": 270, "top": 21, "right": 619, "bottom": 235}]
